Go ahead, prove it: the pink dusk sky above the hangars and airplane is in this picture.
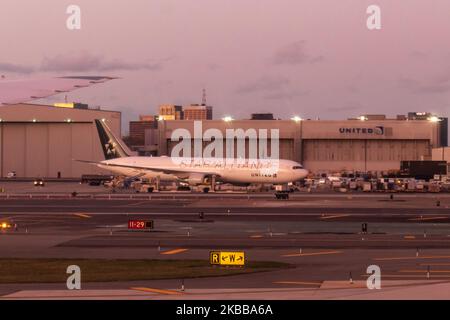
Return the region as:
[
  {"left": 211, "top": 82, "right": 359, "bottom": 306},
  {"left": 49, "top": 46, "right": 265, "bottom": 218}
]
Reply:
[{"left": 0, "top": 0, "right": 450, "bottom": 131}]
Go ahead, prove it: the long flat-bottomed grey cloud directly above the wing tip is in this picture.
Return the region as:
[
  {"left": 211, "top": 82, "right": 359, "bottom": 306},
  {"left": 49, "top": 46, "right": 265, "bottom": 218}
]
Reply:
[{"left": 40, "top": 52, "right": 162, "bottom": 72}]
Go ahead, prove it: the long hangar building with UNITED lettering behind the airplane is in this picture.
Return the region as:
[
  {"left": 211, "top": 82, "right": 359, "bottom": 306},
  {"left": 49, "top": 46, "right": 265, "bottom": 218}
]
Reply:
[{"left": 150, "top": 113, "right": 448, "bottom": 173}]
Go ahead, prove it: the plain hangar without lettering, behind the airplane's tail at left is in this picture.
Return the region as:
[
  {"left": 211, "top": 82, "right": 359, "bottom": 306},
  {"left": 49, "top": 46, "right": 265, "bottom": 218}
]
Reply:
[{"left": 0, "top": 103, "right": 121, "bottom": 178}]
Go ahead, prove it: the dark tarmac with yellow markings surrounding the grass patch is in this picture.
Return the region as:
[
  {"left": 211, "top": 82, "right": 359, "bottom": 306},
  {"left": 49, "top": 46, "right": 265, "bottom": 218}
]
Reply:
[{"left": 0, "top": 190, "right": 450, "bottom": 299}]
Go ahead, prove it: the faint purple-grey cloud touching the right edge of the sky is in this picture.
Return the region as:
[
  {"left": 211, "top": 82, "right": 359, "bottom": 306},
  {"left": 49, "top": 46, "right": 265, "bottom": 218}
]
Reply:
[{"left": 398, "top": 74, "right": 450, "bottom": 94}]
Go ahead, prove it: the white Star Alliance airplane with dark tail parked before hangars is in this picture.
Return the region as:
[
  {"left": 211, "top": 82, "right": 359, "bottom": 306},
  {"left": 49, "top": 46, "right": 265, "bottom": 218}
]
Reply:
[{"left": 77, "top": 119, "right": 308, "bottom": 192}]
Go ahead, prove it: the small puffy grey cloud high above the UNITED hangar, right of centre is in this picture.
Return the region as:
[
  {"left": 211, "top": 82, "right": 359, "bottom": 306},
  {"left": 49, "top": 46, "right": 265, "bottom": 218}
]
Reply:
[{"left": 272, "top": 40, "right": 324, "bottom": 65}]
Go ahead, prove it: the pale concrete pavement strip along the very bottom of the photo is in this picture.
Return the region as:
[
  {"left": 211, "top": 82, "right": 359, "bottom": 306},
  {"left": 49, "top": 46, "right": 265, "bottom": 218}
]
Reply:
[{"left": 7, "top": 280, "right": 450, "bottom": 300}]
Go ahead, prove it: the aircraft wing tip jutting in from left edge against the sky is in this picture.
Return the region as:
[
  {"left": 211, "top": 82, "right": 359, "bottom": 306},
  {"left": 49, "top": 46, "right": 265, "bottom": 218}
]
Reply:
[{"left": 0, "top": 76, "right": 115, "bottom": 105}]
